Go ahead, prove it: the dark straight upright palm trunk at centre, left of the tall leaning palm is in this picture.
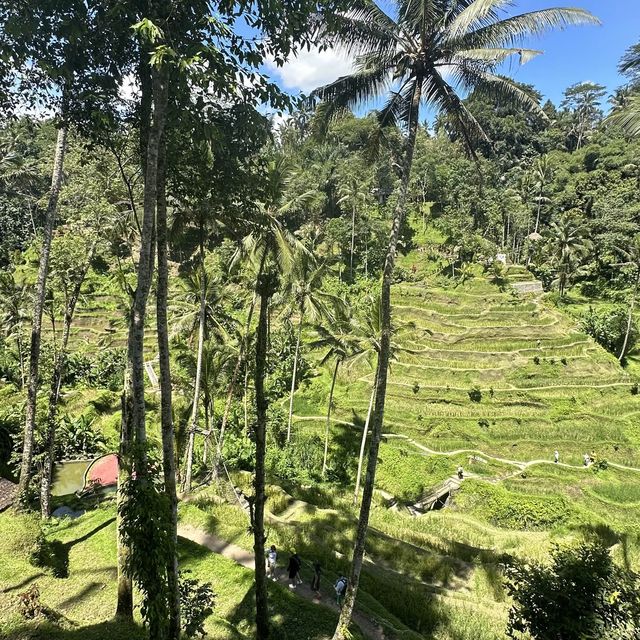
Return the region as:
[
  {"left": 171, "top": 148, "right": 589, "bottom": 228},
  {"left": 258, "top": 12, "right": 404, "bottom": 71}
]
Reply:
[{"left": 251, "top": 274, "right": 272, "bottom": 640}]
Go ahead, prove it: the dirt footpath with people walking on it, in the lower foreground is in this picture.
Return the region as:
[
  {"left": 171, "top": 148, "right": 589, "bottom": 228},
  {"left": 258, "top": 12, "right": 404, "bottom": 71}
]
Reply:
[{"left": 178, "top": 524, "right": 390, "bottom": 640}]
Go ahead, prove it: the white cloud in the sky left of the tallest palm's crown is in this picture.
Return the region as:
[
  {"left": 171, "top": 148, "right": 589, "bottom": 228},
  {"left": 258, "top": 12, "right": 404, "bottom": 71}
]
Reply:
[{"left": 266, "top": 48, "right": 354, "bottom": 93}]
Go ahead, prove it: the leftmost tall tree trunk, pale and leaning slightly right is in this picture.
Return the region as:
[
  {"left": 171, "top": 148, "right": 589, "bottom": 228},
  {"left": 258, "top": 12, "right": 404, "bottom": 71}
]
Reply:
[{"left": 18, "top": 122, "right": 67, "bottom": 505}]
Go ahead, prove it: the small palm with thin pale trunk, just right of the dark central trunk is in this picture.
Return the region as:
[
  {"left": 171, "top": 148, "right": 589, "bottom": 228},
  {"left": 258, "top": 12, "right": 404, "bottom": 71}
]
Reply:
[{"left": 283, "top": 249, "right": 342, "bottom": 442}]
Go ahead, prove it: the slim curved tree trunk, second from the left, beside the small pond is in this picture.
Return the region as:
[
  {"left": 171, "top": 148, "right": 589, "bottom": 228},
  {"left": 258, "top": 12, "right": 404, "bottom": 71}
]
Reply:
[{"left": 40, "top": 239, "right": 98, "bottom": 518}]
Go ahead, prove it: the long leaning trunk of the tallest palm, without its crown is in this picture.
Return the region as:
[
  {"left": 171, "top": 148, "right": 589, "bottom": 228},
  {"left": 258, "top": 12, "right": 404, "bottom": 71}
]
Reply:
[{"left": 333, "top": 78, "right": 422, "bottom": 640}]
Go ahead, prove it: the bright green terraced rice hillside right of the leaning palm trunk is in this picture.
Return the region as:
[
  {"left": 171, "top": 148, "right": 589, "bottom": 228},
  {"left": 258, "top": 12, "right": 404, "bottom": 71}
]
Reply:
[{"left": 295, "top": 255, "right": 640, "bottom": 528}]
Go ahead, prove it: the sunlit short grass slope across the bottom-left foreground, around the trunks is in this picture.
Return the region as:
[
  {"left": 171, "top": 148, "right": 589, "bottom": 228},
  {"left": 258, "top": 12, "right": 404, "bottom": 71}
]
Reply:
[{"left": 0, "top": 505, "right": 361, "bottom": 640}]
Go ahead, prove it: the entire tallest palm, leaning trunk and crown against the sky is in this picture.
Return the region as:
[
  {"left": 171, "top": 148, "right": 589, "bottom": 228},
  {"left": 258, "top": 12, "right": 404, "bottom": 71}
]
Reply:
[{"left": 315, "top": 0, "right": 598, "bottom": 640}]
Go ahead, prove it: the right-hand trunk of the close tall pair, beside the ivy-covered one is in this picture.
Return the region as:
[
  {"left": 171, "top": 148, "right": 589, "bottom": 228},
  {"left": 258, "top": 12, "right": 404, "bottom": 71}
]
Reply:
[{"left": 156, "top": 127, "right": 180, "bottom": 640}]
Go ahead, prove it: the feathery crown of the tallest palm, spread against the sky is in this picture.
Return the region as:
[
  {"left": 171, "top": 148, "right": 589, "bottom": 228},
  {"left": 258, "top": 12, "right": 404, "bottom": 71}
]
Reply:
[{"left": 315, "top": 0, "right": 599, "bottom": 148}]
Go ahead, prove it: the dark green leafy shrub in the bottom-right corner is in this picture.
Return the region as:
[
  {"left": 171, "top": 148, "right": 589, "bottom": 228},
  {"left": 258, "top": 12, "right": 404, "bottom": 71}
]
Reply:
[{"left": 505, "top": 542, "right": 640, "bottom": 640}]
